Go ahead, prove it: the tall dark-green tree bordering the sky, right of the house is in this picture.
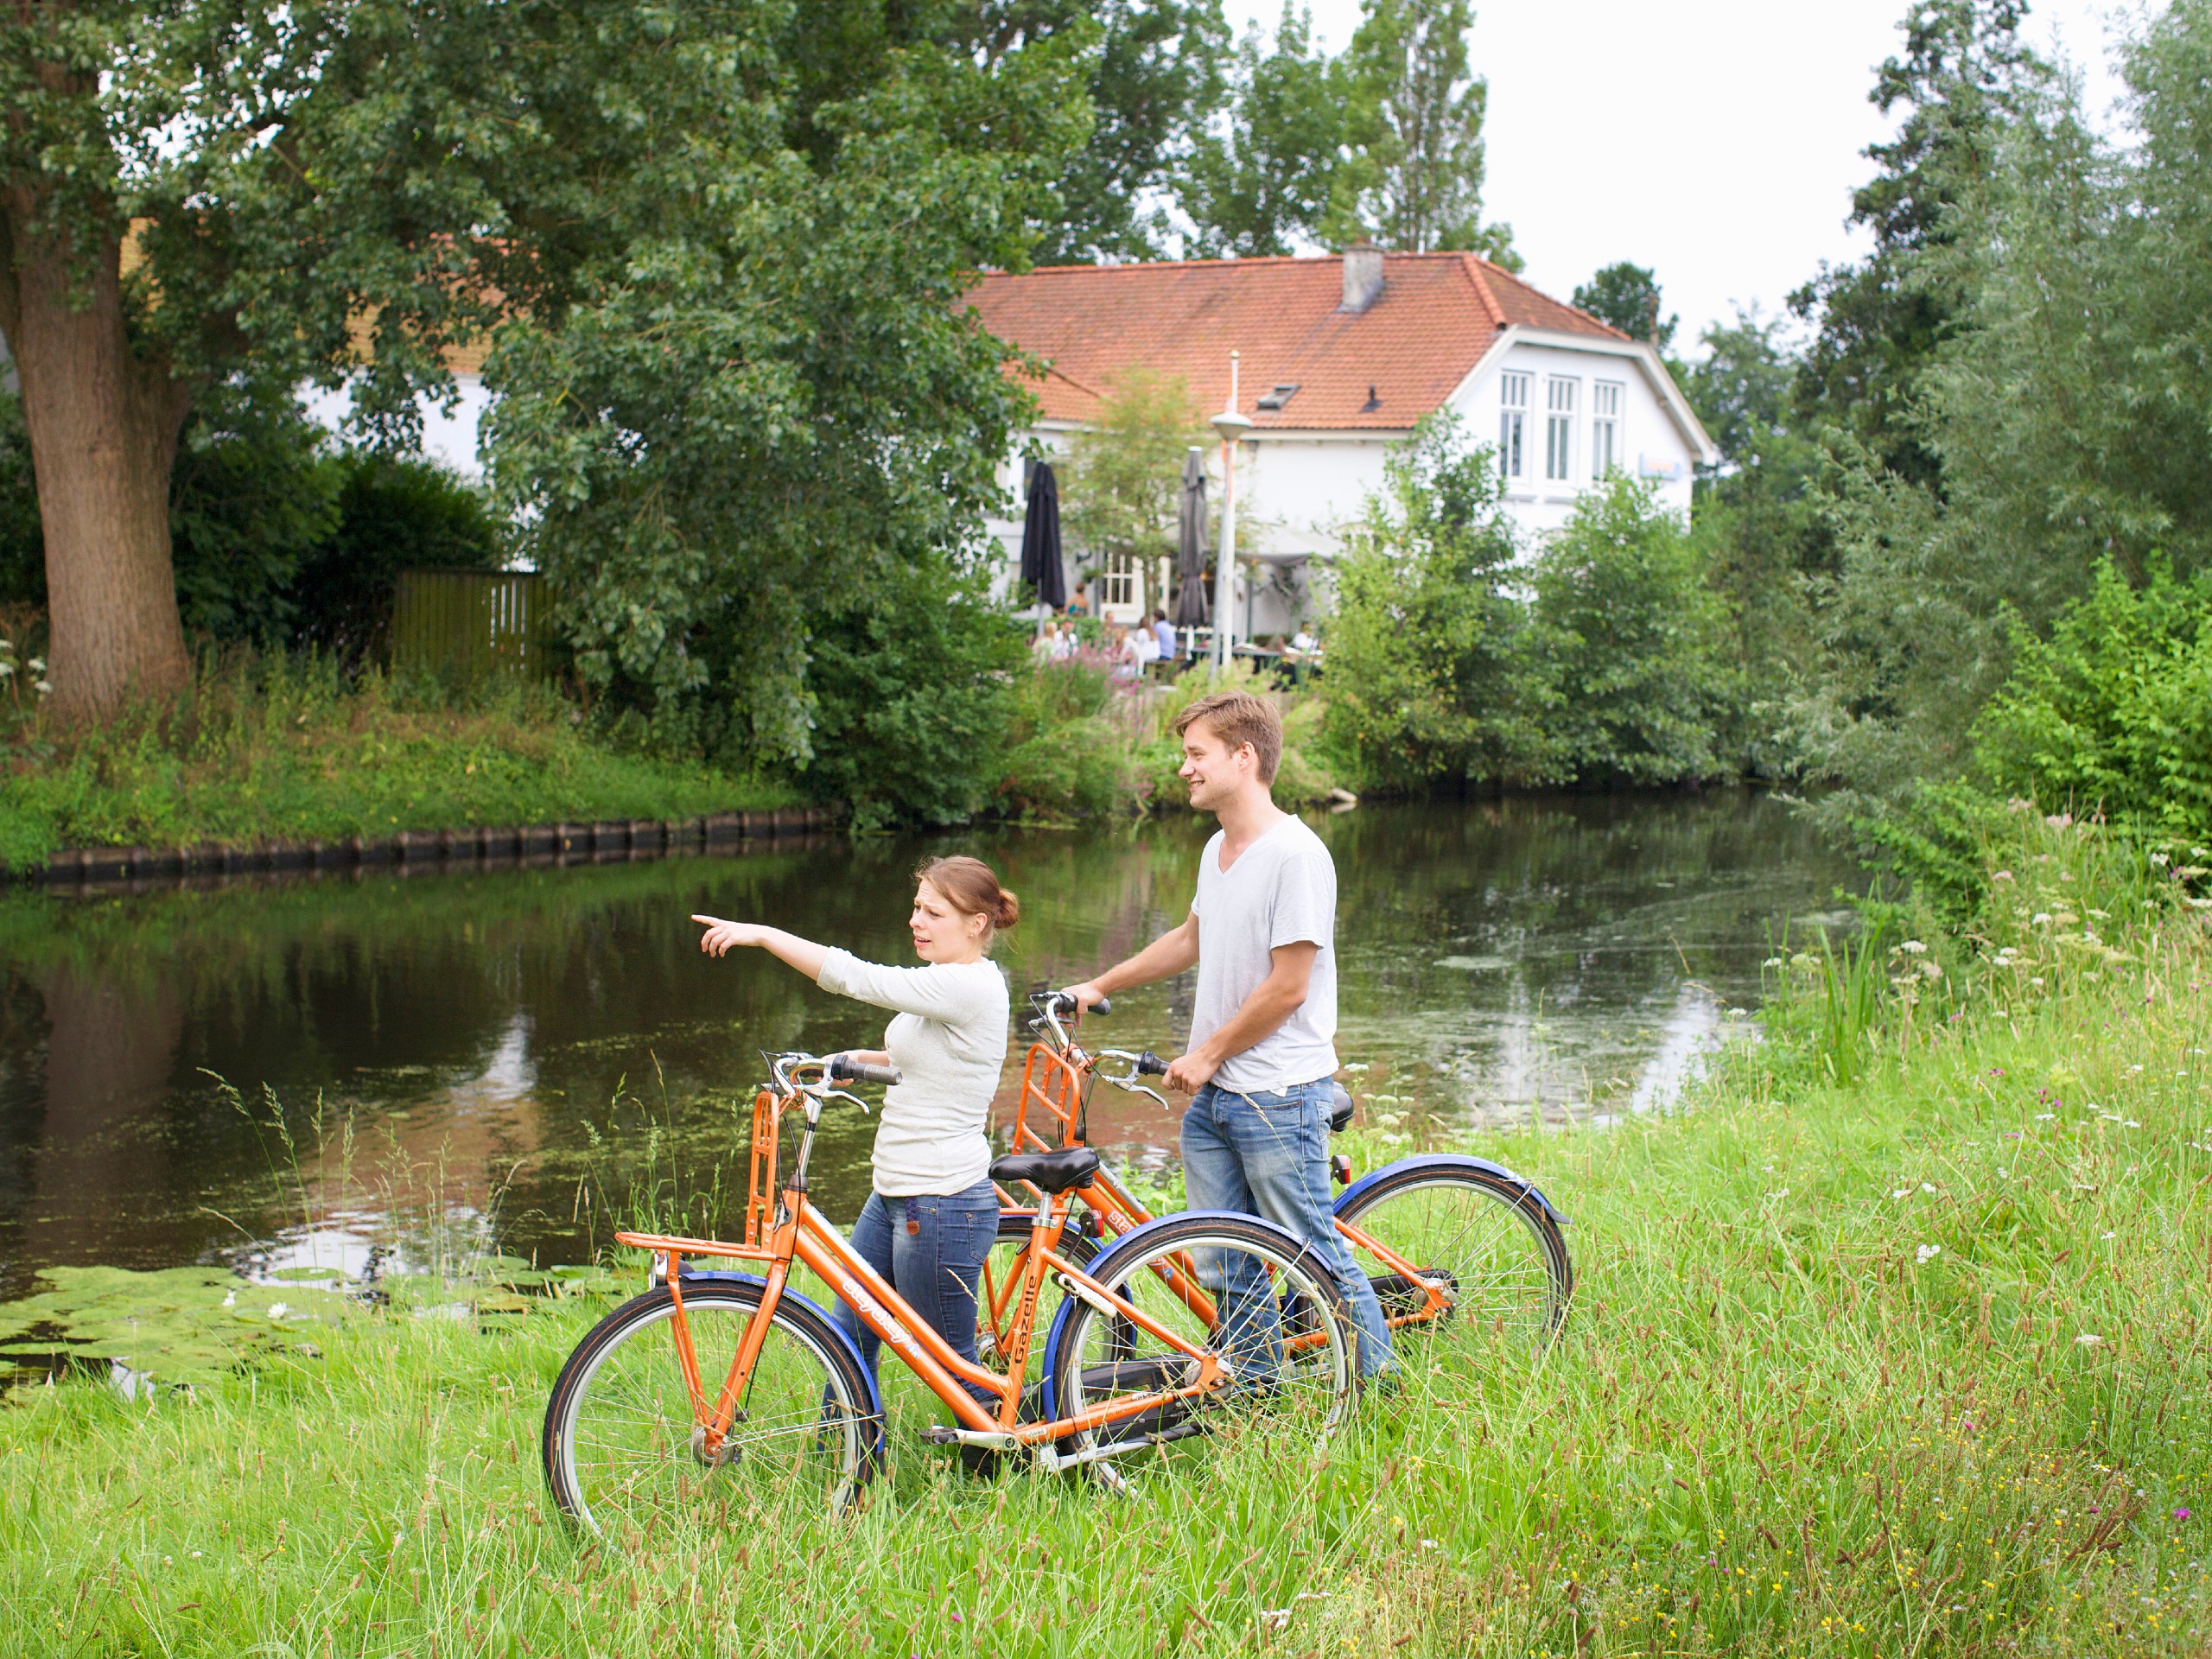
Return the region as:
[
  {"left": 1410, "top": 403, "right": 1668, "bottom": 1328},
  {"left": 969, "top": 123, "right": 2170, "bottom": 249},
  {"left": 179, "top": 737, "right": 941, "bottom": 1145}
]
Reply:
[{"left": 1789, "top": 0, "right": 2044, "bottom": 482}]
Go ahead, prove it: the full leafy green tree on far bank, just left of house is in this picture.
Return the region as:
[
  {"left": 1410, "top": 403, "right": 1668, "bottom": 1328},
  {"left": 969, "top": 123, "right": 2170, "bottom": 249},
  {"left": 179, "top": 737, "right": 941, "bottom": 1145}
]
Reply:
[{"left": 485, "top": 26, "right": 1089, "bottom": 770}]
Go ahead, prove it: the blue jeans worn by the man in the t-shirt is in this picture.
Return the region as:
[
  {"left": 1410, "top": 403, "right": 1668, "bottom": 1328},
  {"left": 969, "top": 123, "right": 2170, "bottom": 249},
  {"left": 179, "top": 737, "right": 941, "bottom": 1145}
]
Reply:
[{"left": 1184, "top": 1077, "right": 1391, "bottom": 1376}]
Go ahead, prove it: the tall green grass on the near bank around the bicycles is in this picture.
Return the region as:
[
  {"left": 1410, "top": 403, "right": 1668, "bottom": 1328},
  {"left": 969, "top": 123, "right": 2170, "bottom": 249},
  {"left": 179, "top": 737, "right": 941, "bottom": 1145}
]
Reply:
[{"left": 0, "top": 827, "right": 2212, "bottom": 1659}]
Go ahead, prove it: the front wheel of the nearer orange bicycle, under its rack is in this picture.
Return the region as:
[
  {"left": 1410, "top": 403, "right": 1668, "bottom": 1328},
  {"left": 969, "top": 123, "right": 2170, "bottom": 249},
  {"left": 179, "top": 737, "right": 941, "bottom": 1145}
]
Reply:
[{"left": 542, "top": 1283, "right": 882, "bottom": 1546}]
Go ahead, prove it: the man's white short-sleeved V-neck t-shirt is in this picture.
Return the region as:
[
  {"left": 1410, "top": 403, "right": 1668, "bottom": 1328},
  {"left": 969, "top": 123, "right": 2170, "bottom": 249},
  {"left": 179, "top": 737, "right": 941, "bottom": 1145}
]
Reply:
[{"left": 1190, "top": 817, "right": 1336, "bottom": 1095}]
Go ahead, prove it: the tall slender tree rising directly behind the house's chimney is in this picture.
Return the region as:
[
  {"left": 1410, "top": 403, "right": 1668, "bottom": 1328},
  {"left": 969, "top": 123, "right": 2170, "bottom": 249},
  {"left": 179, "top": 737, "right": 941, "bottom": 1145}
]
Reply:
[{"left": 1334, "top": 0, "right": 1520, "bottom": 270}]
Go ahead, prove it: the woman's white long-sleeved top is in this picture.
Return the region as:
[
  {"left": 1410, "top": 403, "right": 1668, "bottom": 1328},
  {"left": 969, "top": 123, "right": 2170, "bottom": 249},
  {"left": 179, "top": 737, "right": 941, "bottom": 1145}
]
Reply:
[{"left": 818, "top": 951, "right": 1013, "bottom": 1199}]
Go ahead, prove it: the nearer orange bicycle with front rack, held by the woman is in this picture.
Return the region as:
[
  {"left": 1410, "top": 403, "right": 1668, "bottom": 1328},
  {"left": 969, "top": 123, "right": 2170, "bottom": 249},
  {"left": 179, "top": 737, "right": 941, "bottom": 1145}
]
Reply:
[{"left": 542, "top": 1053, "right": 1358, "bottom": 1537}]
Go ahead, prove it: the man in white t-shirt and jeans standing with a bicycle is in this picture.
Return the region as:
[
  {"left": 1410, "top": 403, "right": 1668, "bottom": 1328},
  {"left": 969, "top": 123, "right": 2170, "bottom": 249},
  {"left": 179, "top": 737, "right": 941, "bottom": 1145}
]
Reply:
[{"left": 1071, "top": 692, "right": 1391, "bottom": 1376}]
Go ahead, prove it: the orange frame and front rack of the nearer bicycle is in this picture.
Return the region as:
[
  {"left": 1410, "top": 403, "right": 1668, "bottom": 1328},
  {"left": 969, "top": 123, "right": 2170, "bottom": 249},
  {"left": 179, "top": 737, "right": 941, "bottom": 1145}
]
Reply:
[{"left": 615, "top": 1086, "right": 1230, "bottom": 1466}]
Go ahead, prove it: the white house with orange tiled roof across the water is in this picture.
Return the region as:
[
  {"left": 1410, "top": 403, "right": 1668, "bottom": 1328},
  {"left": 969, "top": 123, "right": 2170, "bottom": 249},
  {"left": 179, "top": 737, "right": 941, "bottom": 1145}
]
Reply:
[{"left": 969, "top": 244, "right": 1721, "bottom": 635}]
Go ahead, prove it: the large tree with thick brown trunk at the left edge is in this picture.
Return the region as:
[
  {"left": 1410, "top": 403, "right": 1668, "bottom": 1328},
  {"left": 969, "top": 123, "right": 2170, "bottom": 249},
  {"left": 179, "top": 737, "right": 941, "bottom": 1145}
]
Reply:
[{"left": 0, "top": 0, "right": 759, "bottom": 716}]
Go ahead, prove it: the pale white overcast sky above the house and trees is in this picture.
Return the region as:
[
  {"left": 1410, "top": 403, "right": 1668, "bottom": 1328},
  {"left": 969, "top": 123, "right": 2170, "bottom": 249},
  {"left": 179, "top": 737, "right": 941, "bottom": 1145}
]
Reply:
[{"left": 1228, "top": 0, "right": 2133, "bottom": 354}]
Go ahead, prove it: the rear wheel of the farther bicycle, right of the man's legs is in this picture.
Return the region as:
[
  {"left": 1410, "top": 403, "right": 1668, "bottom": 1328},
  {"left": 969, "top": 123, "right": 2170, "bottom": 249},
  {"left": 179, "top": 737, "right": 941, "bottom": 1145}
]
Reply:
[{"left": 1336, "top": 1159, "right": 1575, "bottom": 1365}]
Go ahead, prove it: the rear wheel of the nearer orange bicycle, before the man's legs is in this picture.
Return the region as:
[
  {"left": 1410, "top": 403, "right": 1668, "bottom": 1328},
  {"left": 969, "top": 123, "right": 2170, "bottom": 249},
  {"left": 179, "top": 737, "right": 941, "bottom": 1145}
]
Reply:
[{"left": 1044, "top": 1214, "right": 1358, "bottom": 1451}]
